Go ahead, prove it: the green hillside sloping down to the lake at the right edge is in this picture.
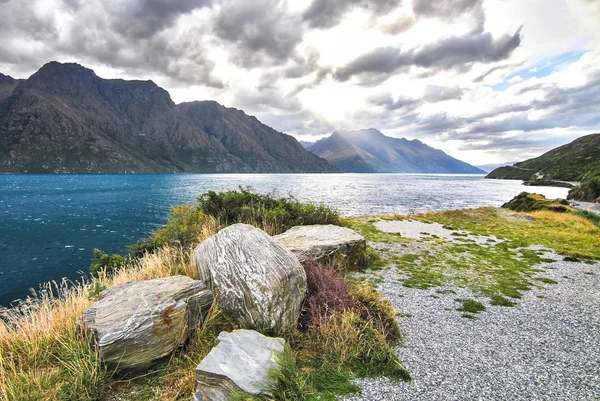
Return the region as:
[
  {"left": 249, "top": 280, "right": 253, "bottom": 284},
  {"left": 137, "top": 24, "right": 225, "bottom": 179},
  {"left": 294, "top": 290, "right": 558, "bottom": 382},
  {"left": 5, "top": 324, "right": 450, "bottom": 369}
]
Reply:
[{"left": 486, "top": 134, "right": 600, "bottom": 181}]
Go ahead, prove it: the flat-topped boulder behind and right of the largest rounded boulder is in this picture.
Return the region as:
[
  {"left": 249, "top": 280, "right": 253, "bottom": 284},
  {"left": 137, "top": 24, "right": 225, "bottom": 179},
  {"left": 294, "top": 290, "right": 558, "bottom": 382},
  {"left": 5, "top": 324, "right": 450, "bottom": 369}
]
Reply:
[{"left": 273, "top": 224, "right": 367, "bottom": 269}]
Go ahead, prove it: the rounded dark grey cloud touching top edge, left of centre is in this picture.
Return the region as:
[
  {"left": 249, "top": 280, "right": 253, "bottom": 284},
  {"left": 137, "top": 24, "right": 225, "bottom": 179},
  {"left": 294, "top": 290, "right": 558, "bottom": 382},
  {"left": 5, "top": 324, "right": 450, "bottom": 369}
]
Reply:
[{"left": 215, "top": 0, "right": 304, "bottom": 67}]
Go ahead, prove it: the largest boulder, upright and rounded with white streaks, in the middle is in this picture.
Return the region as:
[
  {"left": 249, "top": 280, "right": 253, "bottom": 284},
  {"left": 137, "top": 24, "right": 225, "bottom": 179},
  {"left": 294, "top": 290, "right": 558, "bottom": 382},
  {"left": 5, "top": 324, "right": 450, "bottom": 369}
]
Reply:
[{"left": 194, "top": 224, "right": 306, "bottom": 333}]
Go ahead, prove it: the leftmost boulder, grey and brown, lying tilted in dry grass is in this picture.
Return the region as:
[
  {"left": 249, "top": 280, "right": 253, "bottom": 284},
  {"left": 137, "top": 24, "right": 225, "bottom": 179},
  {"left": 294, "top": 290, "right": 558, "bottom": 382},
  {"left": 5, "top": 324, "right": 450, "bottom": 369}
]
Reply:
[{"left": 82, "top": 276, "right": 213, "bottom": 369}]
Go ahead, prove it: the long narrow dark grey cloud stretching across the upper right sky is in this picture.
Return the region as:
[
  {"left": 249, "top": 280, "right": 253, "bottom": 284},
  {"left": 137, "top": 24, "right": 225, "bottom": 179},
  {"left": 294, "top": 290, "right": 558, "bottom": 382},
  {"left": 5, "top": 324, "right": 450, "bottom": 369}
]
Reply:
[{"left": 334, "top": 30, "right": 521, "bottom": 85}]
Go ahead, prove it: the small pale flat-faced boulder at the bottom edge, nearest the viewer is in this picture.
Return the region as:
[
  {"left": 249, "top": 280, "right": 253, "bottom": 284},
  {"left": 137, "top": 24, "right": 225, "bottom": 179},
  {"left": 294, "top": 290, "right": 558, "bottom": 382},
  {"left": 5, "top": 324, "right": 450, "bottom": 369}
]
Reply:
[{"left": 192, "top": 330, "right": 285, "bottom": 401}]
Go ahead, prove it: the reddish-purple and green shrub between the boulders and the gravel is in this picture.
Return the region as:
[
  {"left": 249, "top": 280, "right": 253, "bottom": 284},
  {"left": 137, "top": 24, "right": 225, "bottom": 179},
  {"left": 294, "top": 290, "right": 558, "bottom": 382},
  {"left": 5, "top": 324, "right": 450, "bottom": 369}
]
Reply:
[{"left": 290, "top": 261, "right": 409, "bottom": 400}]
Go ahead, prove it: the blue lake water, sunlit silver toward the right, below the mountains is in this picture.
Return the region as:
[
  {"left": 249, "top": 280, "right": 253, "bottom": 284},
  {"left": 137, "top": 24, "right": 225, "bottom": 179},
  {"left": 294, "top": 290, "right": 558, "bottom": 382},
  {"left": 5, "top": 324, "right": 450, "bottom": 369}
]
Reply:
[{"left": 0, "top": 174, "right": 567, "bottom": 306}]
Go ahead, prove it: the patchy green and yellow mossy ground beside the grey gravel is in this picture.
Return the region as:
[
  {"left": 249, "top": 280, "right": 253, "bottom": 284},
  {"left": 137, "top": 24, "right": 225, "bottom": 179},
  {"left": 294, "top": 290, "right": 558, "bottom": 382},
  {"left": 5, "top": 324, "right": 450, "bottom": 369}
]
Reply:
[{"left": 346, "top": 208, "right": 600, "bottom": 313}]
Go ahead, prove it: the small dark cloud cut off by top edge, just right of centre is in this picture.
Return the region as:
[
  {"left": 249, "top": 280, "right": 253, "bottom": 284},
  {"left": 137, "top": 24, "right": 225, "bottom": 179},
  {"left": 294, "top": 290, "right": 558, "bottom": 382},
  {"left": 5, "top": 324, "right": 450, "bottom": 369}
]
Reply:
[{"left": 302, "top": 0, "right": 401, "bottom": 28}]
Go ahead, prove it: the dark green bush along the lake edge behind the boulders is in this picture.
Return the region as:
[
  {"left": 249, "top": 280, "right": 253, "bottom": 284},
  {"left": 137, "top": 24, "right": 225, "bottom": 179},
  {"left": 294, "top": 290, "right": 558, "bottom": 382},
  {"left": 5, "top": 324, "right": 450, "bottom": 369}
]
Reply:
[{"left": 198, "top": 187, "right": 340, "bottom": 234}]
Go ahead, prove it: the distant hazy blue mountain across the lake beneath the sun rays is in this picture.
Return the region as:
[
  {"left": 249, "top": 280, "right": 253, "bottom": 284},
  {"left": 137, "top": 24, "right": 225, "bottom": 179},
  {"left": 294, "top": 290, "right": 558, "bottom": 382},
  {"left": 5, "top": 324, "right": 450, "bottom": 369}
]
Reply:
[{"left": 309, "top": 129, "right": 484, "bottom": 174}]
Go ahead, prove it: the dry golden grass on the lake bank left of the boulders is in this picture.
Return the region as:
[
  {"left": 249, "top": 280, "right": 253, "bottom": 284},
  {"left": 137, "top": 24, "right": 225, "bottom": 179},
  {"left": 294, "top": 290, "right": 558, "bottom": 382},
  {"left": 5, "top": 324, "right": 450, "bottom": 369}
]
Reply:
[{"left": 0, "top": 219, "right": 219, "bottom": 400}]
